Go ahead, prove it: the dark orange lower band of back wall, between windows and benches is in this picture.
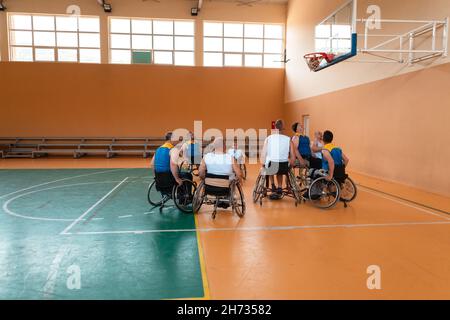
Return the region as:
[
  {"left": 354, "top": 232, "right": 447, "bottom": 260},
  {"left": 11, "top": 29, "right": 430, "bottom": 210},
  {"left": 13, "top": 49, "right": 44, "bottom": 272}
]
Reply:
[{"left": 0, "top": 62, "right": 284, "bottom": 137}]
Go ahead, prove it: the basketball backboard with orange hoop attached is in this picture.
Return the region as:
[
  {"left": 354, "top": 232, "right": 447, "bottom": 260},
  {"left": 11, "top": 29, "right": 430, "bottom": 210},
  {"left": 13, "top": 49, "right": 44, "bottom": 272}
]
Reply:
[{"left": 305, "top": 0, "right": 357, "bottom": 71}]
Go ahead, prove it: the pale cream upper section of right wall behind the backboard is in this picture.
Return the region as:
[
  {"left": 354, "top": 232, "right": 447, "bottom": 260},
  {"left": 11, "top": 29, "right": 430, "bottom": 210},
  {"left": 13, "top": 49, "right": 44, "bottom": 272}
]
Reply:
[{"left": 285, "top": 0, "right": 450, "bottom": 102}]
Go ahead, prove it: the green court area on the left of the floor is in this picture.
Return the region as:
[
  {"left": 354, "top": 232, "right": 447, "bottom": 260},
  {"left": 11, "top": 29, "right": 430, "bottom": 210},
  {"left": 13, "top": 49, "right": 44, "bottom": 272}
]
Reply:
[{"left": 0, "top": 169, "right": 204, "bottom": 299}]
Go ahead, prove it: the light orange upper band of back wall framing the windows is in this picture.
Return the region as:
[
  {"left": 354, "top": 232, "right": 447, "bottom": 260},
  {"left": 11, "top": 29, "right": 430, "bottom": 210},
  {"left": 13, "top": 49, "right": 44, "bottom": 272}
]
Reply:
[{"left": 0, "top": 0, "right": 287, "bottom": 66}]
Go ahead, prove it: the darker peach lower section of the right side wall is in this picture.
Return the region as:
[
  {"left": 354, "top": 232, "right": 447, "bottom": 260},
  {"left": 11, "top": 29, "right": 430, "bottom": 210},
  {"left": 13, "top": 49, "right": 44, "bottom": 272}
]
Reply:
[{"left": 285, "top": 63, "right": 450, "bottom": 196}]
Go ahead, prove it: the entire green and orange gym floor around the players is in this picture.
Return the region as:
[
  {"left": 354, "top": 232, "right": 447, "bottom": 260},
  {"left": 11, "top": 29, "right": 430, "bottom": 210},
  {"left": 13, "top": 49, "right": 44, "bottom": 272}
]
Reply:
[{"left": 0, "top": 159, "right": 450, "bottom": 299}]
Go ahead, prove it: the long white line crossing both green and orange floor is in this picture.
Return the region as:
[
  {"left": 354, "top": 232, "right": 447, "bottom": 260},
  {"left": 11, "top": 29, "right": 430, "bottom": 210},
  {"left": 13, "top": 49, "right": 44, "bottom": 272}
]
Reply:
[{"left": 66, "top": 221, "right": 450, "bottom": 235}]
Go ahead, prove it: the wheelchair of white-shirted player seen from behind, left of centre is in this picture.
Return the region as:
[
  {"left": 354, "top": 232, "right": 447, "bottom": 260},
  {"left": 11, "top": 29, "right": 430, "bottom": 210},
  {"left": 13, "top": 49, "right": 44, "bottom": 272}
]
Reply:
[{"left": 193, "top": 174, "right": 246, "bottom": 219}]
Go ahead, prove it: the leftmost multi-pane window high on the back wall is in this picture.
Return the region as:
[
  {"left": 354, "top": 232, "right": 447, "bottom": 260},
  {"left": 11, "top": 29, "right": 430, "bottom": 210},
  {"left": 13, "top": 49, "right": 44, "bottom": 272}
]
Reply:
[{"left": 9, "top": 13, "right": 100, "bottom": 63}]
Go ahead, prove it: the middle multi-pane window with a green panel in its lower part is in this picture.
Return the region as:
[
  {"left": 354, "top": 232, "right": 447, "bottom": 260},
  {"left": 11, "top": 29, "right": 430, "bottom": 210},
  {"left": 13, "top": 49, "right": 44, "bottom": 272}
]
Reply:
[{"left": 109, "top": 18, "right": 195, "bottom": 66}]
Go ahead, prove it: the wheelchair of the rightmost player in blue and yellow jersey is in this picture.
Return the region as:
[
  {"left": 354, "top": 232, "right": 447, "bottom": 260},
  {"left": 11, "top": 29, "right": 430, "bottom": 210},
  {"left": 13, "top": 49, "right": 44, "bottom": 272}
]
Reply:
[{"left": 299, "top": 166, "right": 358, "bottom": 209}]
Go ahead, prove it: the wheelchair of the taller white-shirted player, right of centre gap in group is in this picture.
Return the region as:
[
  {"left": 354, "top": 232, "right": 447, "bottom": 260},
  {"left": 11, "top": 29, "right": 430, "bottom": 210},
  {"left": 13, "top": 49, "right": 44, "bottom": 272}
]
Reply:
[{"left": 253, "top": 167, "right": 302, "bottom": 207}]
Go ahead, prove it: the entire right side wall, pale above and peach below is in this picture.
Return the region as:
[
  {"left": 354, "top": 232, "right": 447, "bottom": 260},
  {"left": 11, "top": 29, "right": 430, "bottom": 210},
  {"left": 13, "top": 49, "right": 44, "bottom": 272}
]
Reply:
[{"left": 284, "top": 0, "right": 450, "bottom": 196}]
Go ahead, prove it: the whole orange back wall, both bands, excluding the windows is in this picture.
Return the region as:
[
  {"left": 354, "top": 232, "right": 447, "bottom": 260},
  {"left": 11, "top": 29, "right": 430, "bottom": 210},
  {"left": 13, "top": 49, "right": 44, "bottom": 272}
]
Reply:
[{"left": 0, "top": 0, "right": 286, "bottom": 136}]
